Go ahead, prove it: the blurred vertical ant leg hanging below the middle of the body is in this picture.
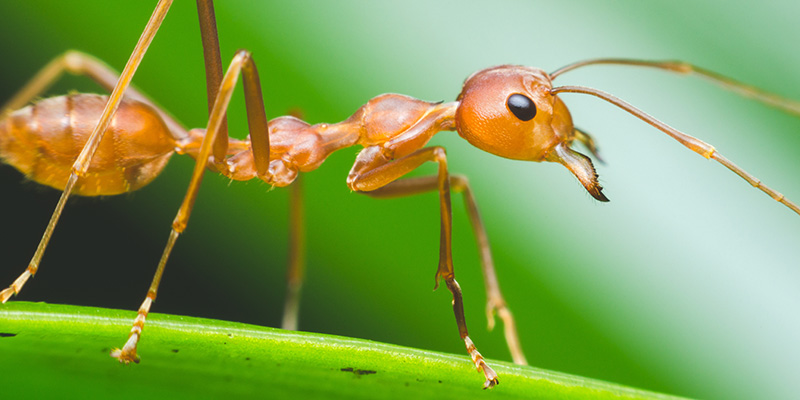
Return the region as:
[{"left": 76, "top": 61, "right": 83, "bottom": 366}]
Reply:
[{"left": 281, "top": 175, "right": 305, "bottom": 331}]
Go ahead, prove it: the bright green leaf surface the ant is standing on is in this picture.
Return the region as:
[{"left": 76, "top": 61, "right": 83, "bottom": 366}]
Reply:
[{"left": 0, "top": 302, "right": 688, "bottom": 400}]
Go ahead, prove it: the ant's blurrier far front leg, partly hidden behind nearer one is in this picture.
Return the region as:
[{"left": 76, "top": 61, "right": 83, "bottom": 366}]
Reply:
[{"left": 364, "top": 175, "right": 528, "bottom": 365}]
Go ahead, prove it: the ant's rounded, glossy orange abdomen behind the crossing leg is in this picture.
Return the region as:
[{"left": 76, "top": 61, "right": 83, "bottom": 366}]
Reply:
[{"left": 0, "top": 94, "right": 176, "bottom": 196}]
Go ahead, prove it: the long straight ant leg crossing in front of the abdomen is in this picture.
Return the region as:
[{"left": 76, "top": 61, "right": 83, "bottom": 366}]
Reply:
[{"left": 0, "top": 0, "right": 172, "bottom": 303}]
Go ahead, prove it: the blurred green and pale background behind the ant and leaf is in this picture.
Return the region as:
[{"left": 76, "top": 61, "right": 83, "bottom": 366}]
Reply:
[{"left": 0, "top": 0, "right": 800, "bottom": 399}]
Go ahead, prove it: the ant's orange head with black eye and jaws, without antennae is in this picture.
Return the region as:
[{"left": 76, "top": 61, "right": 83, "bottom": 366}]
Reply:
[{"left": 455, "top": 65, "right": 608, "bottom": 201}]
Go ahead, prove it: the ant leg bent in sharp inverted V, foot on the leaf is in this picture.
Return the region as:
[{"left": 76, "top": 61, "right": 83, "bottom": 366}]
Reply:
[{"left": 111, "top": 50, "right": 269, "bottom": 364}]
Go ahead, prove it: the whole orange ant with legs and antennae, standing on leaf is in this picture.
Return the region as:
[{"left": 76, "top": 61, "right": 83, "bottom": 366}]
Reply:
[{"left": 0, "top": 0, "right": 800, "bottom": 388}]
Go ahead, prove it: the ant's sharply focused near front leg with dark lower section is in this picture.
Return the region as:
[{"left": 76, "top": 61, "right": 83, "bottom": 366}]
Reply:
[{"left": 347, "top": 146, "right": 498, "bottom": 389}]
